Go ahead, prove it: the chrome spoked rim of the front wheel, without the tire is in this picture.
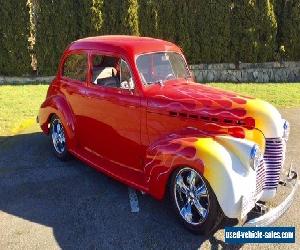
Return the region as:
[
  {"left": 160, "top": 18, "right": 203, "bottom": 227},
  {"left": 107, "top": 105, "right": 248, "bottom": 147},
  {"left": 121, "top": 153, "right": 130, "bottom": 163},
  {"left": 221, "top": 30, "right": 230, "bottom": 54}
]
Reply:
[{"left": 174, "top": 168, "right": 209, "bottom": 225}]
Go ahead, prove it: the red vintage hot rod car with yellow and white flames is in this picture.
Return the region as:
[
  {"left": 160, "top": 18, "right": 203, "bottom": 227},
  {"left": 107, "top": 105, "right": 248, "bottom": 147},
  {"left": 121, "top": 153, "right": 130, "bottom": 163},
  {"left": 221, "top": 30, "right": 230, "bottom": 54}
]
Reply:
[{"left": 37, "top": 36, "right": 297, "bottom": 234}]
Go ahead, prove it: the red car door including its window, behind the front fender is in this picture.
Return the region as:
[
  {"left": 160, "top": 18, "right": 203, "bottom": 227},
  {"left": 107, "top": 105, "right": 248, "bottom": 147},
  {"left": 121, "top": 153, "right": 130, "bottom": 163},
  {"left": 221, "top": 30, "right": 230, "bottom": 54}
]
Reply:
[{"left": 81, "top": 53, "right": 142, "bottom": 171}]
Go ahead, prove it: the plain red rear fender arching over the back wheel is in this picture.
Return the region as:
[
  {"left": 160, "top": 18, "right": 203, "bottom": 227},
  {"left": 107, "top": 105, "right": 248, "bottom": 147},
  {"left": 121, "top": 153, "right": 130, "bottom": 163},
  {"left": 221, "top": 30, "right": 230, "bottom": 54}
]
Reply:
[{"left": 38, "top": 95, "right": 76, "bottom": 146}]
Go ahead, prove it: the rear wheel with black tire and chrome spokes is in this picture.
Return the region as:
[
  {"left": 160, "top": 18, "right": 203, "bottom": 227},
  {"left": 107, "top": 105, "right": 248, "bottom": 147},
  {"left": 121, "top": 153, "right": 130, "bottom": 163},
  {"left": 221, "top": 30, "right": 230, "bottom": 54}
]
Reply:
[{"left": 50, "top": 115, "right": 70, "bottom": 161}]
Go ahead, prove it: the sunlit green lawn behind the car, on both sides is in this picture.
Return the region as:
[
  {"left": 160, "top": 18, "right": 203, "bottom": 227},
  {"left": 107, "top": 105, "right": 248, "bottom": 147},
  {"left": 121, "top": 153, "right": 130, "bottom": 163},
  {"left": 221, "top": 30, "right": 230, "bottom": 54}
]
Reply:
[{"left": 0, "top": 83, "right": 300, "bottom": 136}]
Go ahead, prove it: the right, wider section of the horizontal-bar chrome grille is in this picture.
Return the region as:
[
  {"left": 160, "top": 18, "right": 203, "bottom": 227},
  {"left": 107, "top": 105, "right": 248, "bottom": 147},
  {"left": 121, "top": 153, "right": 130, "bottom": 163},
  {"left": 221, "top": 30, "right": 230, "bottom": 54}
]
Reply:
[{"left": 263, "top": 138, "right": 285, "bottom": 189}]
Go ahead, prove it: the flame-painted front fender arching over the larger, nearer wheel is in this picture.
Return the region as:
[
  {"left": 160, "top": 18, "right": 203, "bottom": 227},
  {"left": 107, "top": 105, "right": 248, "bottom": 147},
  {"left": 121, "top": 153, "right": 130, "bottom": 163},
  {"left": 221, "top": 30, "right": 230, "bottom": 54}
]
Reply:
[{"left": 145, "top": 133, "right": 256, "bottom": 218}]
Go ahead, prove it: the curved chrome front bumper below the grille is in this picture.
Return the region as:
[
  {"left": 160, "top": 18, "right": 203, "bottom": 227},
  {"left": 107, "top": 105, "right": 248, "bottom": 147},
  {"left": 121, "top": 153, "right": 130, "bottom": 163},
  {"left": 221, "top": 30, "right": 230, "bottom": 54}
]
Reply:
[{"left": 243, "top": 171, "right": 298, "bottom": 227}]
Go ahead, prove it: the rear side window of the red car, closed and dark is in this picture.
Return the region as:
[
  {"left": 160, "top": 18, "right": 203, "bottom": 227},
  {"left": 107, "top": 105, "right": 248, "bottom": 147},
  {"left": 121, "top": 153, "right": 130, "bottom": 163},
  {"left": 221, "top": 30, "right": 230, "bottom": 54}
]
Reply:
[{"left": 63, "top": 54, "right": 87, "bottom": 82}]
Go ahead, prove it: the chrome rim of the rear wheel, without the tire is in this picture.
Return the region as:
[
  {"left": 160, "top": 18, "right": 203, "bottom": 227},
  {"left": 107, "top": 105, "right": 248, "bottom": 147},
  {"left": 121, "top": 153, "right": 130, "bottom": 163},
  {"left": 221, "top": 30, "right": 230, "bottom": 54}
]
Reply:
[{"left": 51, "top": 119, "right": 66, "bottom": 154}]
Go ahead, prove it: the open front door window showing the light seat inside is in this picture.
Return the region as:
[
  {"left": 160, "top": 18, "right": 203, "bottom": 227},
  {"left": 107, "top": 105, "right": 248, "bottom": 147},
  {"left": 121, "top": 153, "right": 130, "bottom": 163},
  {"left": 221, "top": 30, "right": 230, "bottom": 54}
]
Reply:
[{"left": 92, "top": 55, "right": 133, "bottom": 89}]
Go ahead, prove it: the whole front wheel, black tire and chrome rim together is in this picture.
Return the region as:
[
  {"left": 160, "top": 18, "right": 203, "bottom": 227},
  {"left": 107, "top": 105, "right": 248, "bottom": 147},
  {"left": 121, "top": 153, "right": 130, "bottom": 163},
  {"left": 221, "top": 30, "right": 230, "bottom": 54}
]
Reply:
[{"left": 170, "top": 167, "right": 223, "bottom": 235}]
